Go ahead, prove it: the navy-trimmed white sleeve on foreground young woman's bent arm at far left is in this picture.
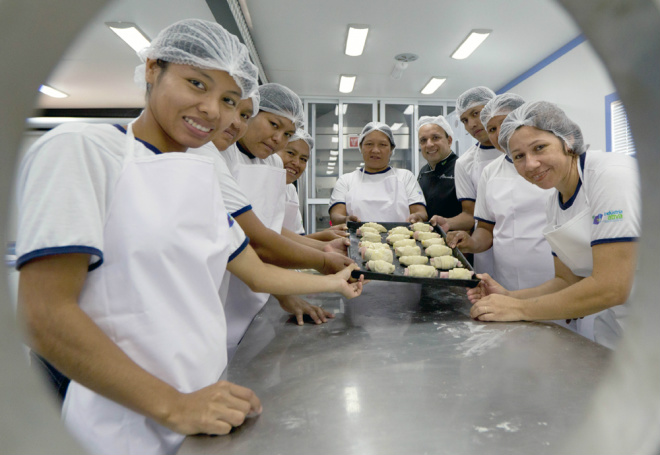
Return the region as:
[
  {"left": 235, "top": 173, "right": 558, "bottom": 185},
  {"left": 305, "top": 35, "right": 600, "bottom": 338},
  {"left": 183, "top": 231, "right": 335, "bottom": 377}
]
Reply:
[{"left": 16, "top": 130, "right": 114, "bottom": 270}]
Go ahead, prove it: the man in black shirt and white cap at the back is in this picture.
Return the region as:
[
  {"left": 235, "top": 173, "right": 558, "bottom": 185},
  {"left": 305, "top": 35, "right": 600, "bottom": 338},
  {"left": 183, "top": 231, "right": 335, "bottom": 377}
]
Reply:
[{"left": 417, "top": 115, "right": 463, "bottom": 218}]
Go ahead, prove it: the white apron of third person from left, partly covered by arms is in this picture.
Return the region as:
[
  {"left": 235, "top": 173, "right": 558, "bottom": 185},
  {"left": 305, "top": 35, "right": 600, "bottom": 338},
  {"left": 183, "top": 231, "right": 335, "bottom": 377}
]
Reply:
[{"left": 225, "top": 157, "right": 286, "bottom": 359}]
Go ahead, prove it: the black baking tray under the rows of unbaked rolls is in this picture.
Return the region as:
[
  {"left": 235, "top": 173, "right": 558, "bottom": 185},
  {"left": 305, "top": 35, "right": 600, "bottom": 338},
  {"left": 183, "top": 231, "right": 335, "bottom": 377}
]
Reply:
[{"left": 346, "top": 221, "right": 481, "bottom": 288}]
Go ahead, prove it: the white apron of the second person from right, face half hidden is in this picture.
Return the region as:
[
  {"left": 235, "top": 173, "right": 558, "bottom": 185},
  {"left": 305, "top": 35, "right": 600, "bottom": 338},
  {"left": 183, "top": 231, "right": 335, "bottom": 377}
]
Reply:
[{"left": 486, "top": 161, "right": 555, "bottom": 291}]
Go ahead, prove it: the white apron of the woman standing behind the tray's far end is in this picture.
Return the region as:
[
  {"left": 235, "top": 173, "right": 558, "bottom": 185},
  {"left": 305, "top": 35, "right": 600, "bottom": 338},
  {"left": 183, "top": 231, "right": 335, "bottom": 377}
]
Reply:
[{"left": 346, "top": 169, "right": 410, "bottom": 222}]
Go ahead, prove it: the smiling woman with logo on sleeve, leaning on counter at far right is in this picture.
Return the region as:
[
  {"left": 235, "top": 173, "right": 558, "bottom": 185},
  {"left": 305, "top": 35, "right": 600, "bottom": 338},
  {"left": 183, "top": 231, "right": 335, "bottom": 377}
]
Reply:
[{"left": 468, "top": 102, "right": 640, "bottom": 348}]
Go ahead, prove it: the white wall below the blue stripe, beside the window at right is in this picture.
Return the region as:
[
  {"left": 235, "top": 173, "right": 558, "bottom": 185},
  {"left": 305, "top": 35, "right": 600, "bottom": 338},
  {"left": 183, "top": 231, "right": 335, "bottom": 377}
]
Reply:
[{"left": 507, "top": 41, "right": 615, "bottom": 150}]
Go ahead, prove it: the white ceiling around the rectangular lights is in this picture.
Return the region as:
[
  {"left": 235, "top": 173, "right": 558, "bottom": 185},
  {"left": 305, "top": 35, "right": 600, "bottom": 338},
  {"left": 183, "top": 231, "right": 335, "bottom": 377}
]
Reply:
[{"left": 37, "top": 0, "right": 580, "bottom": 108}]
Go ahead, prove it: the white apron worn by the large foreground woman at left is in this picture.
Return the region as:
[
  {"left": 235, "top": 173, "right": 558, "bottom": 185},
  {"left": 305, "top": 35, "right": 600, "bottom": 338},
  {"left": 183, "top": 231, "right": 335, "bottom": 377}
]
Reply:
[{"left": 63, "top": 126, "right": 230, "bottom": 455}]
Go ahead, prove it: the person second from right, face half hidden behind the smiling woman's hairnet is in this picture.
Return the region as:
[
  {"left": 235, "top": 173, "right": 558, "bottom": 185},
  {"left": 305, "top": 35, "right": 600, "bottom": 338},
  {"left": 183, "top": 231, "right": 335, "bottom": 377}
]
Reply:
[{"left": 447, "top": 93, "right": 554, "bottom": 291}]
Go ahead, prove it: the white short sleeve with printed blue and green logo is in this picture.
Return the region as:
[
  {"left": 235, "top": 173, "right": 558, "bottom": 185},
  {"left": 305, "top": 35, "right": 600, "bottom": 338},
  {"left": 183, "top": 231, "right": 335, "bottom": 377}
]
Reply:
[{"left": 585, "top": 155, "right": 641, "bottom": 246}]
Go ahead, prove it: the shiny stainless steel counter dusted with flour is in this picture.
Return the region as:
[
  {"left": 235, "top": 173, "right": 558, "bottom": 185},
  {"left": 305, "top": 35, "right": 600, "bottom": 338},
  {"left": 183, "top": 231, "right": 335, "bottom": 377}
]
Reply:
[{"left": 179, "top": 282, "right": 611, "bottom": 455}]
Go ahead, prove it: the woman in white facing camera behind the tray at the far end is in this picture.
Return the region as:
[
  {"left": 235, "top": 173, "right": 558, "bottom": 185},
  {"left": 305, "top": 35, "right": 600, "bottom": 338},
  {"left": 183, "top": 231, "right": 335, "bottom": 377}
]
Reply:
[{"left": 330, "top": 122, "right": 428, "bottom": 225}]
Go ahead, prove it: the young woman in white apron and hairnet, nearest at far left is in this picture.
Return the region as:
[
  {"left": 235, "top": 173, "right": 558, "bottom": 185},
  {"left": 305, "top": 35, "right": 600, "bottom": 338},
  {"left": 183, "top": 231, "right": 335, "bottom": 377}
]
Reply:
[{"left": 16, "top": 20, "right": 361, "bottom": 454}]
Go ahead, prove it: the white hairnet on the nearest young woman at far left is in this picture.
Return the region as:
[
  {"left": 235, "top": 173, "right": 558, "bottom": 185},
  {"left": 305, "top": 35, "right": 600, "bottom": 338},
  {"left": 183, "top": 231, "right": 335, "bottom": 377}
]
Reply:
[{"left": 135, "top": 19, "right": 258, "bottom": 98}]
